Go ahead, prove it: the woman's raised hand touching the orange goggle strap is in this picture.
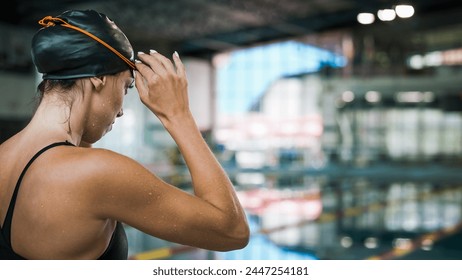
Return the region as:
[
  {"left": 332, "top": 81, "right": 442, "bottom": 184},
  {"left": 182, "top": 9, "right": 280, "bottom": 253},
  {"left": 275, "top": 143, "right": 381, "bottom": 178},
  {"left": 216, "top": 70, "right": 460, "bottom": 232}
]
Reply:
[{"left": 135, "top": 51, "right": 190, "bottom": 125}]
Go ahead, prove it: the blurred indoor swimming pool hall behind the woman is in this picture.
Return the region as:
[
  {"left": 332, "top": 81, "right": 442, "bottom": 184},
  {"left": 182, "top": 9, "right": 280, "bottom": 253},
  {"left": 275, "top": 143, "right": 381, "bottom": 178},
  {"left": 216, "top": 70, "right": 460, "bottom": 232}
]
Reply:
[{"left": 0, "top": 0, "right": 462, "bottom": 260}]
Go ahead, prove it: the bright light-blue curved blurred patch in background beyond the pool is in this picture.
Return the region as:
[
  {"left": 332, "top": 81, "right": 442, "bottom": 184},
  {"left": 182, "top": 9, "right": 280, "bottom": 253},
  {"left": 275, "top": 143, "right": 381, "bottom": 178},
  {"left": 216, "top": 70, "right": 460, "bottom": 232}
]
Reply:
[{"left": 217, "top": 41, "right": 347, "bottom": 114}]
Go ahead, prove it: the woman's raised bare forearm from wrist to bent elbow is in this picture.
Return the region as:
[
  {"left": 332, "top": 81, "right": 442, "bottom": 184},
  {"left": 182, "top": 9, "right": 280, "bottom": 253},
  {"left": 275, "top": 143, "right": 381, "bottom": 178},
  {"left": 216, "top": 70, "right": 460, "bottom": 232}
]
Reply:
[{"left": 164, "top": 110, "right": 249, "bottom": 246}]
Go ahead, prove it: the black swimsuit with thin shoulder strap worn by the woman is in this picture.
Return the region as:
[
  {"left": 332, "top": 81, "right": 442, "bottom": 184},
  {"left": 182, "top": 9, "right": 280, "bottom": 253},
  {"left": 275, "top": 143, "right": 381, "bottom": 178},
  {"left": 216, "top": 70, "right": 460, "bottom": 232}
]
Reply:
[{"left": 0, "top": 141, "right": 128, "bottom": 260}]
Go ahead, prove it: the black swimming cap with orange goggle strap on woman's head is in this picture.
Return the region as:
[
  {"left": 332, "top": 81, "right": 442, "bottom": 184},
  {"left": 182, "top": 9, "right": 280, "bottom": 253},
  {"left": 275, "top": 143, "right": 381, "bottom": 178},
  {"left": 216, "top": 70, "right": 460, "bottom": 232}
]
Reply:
[{"left": 31, "top": 10, "right": 134, "bottom": 80}]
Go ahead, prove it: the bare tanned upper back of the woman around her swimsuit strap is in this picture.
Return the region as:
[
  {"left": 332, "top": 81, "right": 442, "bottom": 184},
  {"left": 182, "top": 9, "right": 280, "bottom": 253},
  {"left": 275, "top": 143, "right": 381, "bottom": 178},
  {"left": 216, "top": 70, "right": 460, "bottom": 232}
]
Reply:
[{"left": 0, "top": 137, "right": 126, "bottom": 259}]
